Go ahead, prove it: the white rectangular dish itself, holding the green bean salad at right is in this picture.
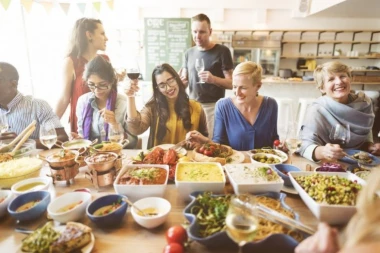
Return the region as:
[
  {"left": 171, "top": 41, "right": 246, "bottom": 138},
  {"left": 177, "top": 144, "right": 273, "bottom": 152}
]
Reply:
[{"left": 289, "top": 171, "right": 365, "bottom": 225}]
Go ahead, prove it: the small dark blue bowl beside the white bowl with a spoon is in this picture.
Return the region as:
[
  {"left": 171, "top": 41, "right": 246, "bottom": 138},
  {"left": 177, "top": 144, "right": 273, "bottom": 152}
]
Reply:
[{"left": 86, "top": 194, "right": 128, "bottom": 227}]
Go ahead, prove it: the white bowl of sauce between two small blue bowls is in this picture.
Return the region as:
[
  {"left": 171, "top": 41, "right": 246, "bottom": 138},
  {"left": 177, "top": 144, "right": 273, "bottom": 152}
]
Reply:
[{"left": 47, "top": 192, "right": 91, "bottom": 223}]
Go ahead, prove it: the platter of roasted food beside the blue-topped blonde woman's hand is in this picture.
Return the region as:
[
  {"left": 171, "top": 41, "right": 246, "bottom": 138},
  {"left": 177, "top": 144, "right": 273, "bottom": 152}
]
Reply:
[{"left": 193, "top": 143, "right": 245, "bottom": 165}]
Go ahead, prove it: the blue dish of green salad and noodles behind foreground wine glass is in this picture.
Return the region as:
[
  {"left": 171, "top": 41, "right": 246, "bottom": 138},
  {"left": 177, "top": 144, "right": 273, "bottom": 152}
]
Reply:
[{"left": 183, "top": 192, "right": 306, "bottom": 252}]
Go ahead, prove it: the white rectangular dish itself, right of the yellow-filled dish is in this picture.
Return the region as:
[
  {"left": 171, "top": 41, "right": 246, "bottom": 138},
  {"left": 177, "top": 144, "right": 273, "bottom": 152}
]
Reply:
[{"left": 224, "top": 163, "right": 284, "bottom": 194}]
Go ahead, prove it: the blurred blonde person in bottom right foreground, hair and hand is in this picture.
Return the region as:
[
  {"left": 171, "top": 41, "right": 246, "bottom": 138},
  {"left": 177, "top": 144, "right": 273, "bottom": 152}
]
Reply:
[{"left": 295, "top": 169, "right": 380, "bottom": 253}]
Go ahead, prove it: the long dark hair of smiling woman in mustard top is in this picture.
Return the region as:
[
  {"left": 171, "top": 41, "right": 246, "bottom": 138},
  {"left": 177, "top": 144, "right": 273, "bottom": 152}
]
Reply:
[{"left": 147, "top": 63, "right": 192, "bottom": 141}]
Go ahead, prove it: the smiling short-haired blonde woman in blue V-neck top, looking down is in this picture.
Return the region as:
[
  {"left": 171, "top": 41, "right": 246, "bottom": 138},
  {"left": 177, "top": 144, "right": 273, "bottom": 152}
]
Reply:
[{"left": 188, "top": 61, "right": 278, "bottom": 150}]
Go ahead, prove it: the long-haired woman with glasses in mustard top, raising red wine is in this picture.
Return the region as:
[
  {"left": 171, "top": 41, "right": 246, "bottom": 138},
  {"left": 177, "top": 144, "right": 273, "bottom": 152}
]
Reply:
[{"left": 125, "top": 63, "right": 208, "bottom": 148}]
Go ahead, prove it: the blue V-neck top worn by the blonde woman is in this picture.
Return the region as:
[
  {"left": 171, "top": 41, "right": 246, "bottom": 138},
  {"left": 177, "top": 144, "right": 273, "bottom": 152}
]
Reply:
[{"left": 213, "top": 96, "right": 278, "bottom": 150}]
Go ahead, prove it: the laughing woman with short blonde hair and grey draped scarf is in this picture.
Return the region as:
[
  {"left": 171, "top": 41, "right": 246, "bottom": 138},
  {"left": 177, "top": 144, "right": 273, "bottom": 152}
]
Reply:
[{"left": 300, "top": 62, "right": 380, "bottom": 161}]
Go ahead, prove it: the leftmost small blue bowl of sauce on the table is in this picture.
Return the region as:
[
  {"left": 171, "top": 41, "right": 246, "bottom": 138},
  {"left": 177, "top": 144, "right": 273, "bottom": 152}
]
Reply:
[{"left": 8, "top": 191, "right": 50, "bottom": 221}]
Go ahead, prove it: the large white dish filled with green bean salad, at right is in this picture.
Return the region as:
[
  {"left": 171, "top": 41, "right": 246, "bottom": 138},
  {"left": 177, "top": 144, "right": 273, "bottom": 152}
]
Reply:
[{"left": 289, "top": 171, "right": 365, "bottom": 224}]
